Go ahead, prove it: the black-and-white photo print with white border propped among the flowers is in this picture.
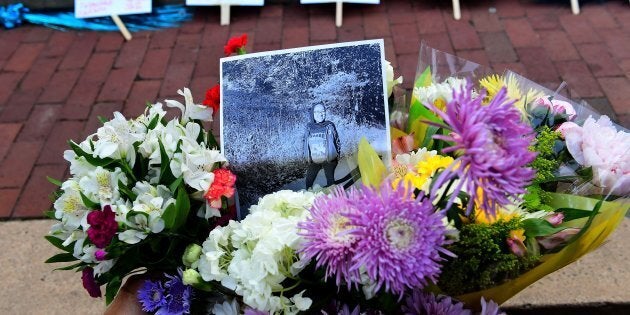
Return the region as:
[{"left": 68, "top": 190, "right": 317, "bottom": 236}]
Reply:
[{"left": 221, "top": 40, "right": 391, "bottom": 217}]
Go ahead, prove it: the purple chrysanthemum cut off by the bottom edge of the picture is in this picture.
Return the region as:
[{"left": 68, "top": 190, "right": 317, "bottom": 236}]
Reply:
[{"left": 402, "top": 290, "right": 472, "bottom": 315}]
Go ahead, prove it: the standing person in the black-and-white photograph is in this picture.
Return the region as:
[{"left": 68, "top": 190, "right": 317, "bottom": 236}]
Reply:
[{"left": 304, "top": 104, "right": 341, "bottom": 189}]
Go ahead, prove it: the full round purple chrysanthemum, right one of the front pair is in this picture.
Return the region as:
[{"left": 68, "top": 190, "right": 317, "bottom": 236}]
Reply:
[{"left": 347, "top": 181, "right": 452, "bottom": 297}]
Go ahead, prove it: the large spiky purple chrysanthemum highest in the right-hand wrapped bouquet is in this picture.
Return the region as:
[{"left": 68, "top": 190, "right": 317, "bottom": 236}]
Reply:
[{"left": 431, "top": 83, "right": 536, "bottom": 216}]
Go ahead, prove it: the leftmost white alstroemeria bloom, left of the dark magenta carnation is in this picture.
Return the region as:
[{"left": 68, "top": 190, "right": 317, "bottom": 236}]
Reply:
[{"left": 53, "top": 180, "right": 91, "bottom": 230}]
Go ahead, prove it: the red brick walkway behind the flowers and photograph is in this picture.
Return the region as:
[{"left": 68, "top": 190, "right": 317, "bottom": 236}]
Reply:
[{"left": 0, "top": 0, "right": 630, "bottom": 218}]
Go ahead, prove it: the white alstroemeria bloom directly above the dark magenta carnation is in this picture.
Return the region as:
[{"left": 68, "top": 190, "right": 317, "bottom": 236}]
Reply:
[{"left": 79, "top": 166, "right": 127, "bottom": 205}]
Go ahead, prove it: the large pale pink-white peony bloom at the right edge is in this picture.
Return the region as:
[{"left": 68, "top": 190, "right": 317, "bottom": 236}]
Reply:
[{"left": 561, "top": 115, "right": 630, "bottom": 196}]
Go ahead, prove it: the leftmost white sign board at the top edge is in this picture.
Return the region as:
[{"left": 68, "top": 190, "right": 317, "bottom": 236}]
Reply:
[{"left": 74, "top": 0, "right": 151, "bottom": 19}]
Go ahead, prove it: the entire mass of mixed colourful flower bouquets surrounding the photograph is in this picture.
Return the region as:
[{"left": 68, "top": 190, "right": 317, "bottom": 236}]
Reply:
[{"left": 47, "top": 38, "right": 630, "bottom": 314}]
